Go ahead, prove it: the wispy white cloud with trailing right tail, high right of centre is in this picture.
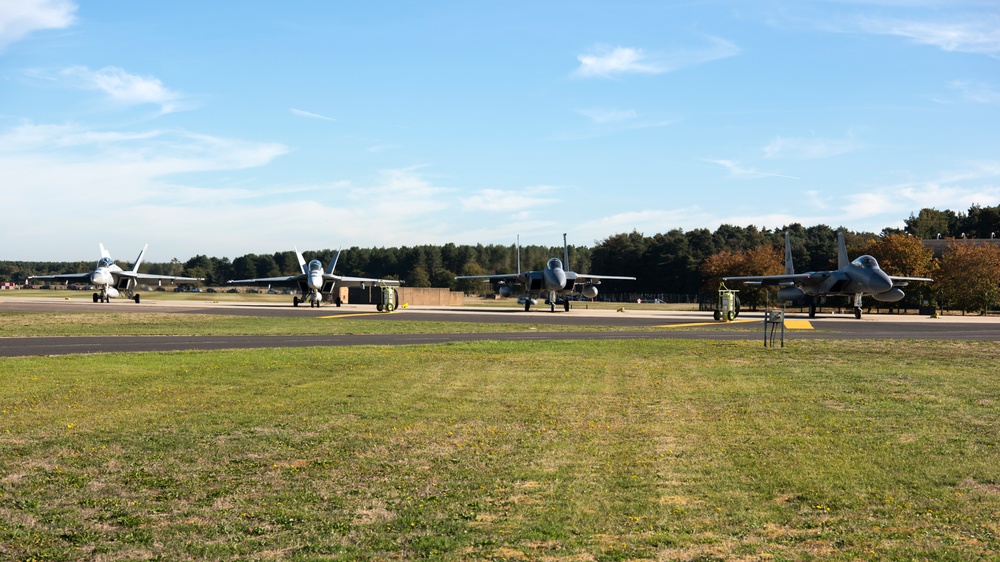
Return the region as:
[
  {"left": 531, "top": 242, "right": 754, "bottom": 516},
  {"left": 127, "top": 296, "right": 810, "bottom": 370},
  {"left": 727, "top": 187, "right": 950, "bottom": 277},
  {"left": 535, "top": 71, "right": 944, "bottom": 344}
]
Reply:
[{"left": 573, "top": 37, "right": 740, "bottom": 78}]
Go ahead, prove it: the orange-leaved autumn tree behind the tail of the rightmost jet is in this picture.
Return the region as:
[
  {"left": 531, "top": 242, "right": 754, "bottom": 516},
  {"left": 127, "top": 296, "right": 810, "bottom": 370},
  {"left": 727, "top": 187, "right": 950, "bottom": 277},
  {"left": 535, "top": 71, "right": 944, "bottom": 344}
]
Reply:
[{"left": 698, "top": 246, "right": 785, "bottom": 310}]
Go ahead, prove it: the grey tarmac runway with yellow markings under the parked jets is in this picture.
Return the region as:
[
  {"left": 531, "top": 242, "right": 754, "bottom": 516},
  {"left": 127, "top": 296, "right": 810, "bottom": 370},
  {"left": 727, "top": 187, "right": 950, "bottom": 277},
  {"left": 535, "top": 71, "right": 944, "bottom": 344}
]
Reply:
[{"left": 0, "top": 298, "right": 1000, "bottom": 357}]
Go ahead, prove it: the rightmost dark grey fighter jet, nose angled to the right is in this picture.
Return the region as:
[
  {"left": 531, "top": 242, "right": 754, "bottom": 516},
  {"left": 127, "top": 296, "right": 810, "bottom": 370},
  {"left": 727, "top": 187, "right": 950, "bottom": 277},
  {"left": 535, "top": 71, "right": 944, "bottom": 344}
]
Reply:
[{"left": 722, "top": 229, "right": 933, "bottom": 320}]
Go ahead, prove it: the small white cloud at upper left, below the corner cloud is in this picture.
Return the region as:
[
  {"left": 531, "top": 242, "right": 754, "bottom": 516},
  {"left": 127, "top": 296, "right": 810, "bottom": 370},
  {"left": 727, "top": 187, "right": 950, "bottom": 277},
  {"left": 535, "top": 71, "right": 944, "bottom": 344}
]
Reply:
[{"left": 60, "top": 66, "right": 183, "bottom": 114}]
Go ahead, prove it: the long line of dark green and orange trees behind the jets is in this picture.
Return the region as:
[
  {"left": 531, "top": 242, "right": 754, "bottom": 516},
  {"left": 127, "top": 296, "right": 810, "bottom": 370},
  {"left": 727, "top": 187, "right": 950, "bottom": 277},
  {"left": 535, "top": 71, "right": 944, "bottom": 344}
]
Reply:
[{"left": 0, "top": 205, "right": 1000, "bottom": 310}]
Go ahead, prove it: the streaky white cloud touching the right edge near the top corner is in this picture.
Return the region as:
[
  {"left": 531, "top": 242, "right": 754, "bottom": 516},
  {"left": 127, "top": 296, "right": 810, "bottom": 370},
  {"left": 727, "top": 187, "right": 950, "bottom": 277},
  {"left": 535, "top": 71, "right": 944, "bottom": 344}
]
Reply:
[{"left": 860, "top": 15, "right": 1000, "bottom": 57}]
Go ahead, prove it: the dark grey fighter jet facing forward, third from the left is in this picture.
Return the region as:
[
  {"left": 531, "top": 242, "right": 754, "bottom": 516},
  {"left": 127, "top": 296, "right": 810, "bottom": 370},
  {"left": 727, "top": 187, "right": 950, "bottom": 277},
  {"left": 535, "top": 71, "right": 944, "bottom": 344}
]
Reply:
[{"left": 455, "top": 234, "right": 635, "bottom": 312}]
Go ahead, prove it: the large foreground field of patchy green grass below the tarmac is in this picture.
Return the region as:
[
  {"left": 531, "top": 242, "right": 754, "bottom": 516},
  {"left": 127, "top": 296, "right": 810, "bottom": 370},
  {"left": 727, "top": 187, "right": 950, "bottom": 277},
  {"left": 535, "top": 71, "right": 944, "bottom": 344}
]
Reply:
[{"left": 0, "top": 334, "right": 1000, "bottom": 561}]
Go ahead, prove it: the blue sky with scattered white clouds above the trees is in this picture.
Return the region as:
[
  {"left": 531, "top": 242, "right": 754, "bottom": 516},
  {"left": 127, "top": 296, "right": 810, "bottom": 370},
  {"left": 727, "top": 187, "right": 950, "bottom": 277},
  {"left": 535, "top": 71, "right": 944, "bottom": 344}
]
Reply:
[{"left": 0, "top": 0, "right": 1000, "bottom": 261}]
